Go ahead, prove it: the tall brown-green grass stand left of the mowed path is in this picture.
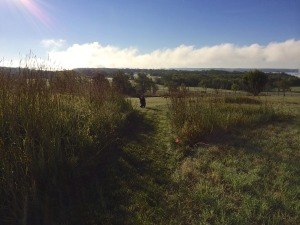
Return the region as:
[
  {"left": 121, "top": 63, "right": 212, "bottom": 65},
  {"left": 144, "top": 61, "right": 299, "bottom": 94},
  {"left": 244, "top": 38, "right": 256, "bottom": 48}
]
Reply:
[{"left": 0, "top": 70, "right": 133, "bottom": 224}]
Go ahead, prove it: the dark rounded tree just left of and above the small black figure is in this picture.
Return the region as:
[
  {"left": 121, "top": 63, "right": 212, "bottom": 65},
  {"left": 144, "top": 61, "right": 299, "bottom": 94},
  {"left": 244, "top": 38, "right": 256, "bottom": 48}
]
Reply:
[{"left": 112, "top": 71, "right": 135, "bottom": 95}]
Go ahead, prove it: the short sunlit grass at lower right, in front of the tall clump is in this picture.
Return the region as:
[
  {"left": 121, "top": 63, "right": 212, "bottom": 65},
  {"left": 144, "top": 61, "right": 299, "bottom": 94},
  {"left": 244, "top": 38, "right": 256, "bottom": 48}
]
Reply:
[{"left": 169, "top": 123, "right": 300, "bottom": 224}]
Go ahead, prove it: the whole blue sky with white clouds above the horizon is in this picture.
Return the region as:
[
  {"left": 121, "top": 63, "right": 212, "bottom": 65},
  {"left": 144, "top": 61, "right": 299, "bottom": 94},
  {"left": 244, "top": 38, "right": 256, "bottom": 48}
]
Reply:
[{"left": 0, "top": 0, "right": 300, "bottom": 69}]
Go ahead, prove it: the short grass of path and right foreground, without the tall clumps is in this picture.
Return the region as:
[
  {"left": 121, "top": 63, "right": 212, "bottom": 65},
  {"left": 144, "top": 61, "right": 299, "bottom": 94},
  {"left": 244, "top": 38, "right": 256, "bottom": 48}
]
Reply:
[{"left": 102, "top": 97, "right": 300, "bottom": 225}]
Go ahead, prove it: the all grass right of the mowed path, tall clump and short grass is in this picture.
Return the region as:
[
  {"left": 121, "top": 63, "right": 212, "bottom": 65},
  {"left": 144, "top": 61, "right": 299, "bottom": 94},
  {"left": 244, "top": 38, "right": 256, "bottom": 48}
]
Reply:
[{"left": 167, "top": 94, "right": 300, "bottom": 224}]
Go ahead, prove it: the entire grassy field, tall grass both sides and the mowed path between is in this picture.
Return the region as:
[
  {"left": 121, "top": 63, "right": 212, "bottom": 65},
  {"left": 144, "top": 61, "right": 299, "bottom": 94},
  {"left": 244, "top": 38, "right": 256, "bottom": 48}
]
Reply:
[{"left": 0, "top": 71, "right": 300, "bottom": 225}]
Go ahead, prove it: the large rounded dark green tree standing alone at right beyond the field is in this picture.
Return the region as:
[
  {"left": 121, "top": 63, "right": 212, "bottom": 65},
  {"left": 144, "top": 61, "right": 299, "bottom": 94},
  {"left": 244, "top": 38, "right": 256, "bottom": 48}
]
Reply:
[{"left": 243, "top": 70, "right": 268, "bottom": 96}]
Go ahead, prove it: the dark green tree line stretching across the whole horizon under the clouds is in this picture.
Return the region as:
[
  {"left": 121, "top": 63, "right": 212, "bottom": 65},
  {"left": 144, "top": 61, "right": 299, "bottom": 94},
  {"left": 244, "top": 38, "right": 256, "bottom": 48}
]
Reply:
[{"left": 1, "top": 68, "right": 300, "bottom": 96}]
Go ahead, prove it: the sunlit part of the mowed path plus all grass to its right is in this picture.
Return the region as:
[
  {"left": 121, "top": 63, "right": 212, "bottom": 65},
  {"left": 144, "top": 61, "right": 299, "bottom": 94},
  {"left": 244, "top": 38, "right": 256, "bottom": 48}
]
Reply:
[{"left": 119, "top": 96, "right": 300, "bottom": 224}]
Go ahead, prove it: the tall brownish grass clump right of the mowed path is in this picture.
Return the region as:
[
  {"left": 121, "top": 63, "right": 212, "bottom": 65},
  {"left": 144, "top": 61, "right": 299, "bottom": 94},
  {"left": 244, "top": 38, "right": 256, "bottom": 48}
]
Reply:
[{"left": 170, "top": 95, "right": 278, "bottom": 145}]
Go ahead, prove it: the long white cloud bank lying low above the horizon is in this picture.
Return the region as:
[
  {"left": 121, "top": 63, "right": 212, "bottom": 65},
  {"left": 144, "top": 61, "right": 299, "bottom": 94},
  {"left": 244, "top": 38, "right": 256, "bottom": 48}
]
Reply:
[{"left": 44, "top": 39, "right": 300, "bottom": 69}]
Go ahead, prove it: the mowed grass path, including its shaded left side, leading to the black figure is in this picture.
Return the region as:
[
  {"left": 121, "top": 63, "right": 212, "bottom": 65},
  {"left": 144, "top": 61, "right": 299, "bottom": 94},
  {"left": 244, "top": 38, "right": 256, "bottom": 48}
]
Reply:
[{"left": 92, "top": 98, "right": 174, "bottom": 224}]
